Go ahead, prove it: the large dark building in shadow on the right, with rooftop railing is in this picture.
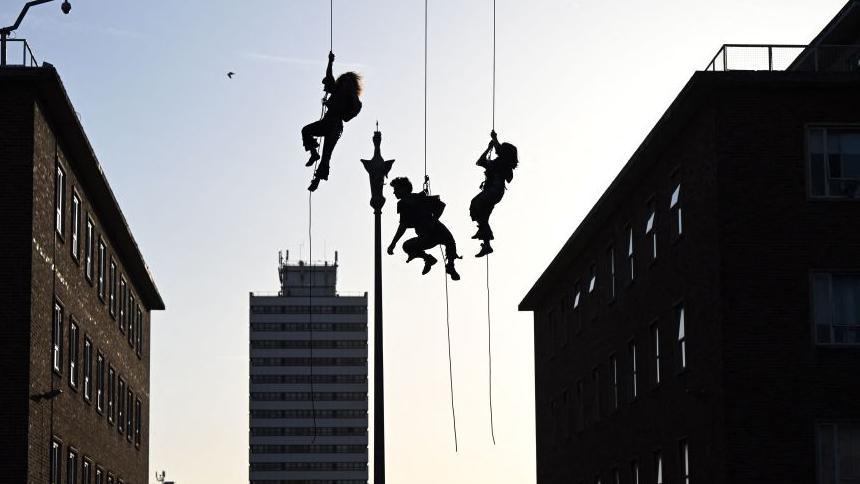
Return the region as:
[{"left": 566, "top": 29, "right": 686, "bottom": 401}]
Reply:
[{"left": 520, "top": 1, "right": 860, "bottom": 484}]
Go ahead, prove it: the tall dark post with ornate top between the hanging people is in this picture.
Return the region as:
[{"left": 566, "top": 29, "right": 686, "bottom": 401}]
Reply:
[{"left": 361, "top": 123, "right": 394, "bottom": 484}]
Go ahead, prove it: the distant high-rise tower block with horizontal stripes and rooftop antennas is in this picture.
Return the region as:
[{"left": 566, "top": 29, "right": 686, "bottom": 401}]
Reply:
[{"left": 249, "top": 253, "right": 368, "bottom": 484}]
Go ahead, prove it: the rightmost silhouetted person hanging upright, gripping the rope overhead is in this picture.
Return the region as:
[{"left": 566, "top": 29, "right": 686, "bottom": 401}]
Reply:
[{"left": 469, "top": 131, "right": 519, "bottom": 257}]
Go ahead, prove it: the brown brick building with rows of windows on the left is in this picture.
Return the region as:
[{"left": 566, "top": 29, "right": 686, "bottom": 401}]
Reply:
[{"left": 0, "top": 64, "right": 164, "bottom": 484}]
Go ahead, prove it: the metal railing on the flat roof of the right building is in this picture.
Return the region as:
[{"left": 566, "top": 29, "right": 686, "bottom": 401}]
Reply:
[{"left": 705, "top": 44, "right": 860, "bottom": 72}]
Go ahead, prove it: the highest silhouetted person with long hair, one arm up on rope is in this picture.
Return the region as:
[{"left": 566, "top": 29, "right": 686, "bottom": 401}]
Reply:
[{"left": 302, "top": 52, "right": 361, "bottom": 191}]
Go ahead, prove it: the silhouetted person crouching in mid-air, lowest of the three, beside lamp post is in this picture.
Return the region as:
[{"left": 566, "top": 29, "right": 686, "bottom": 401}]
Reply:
[{"left": 388, "top": 177, "right": 461, "bottom": 281}]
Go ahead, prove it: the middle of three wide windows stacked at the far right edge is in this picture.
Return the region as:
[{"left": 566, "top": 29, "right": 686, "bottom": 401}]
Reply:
[{"left": 812, "top": 273, "right": 860, "bottom": 345}]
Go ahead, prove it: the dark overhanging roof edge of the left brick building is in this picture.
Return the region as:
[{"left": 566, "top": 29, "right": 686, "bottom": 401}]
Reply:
[{"left": 0, "top": 64, "right": 164, "bottom": 310}]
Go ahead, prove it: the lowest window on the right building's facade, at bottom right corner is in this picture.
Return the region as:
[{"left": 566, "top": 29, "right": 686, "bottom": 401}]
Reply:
[{"left": 817, "top": 422, "right": 860, "bottom": 484}]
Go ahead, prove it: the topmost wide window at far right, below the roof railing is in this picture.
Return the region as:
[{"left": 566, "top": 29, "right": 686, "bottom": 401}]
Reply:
[{"left": 809, "top": 127, "right": 860, "bottom": 199}]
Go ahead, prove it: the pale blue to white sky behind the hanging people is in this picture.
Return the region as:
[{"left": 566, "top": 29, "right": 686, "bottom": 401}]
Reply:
[{"left": 0, "top": 0, "right": 844, "bottom": 484}]
